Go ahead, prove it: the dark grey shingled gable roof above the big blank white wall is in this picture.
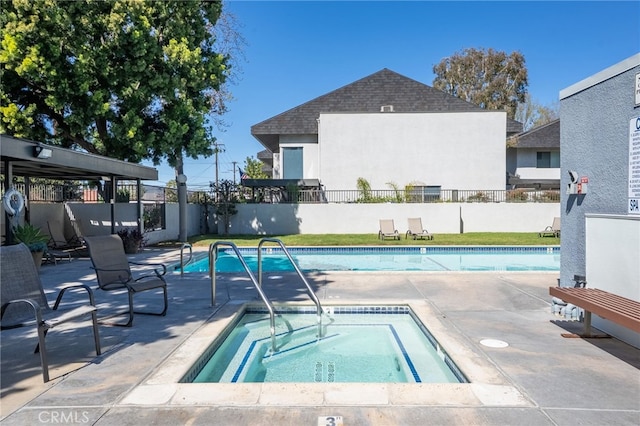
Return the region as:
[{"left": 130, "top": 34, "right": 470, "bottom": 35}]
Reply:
[{"left": 251, "top": 68, "right": 522, "bottom": 152}]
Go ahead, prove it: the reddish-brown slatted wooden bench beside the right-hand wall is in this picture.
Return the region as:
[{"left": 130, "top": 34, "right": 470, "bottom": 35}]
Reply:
[{"left": 549, "top": 287, "right": 640, "bottom": 337}]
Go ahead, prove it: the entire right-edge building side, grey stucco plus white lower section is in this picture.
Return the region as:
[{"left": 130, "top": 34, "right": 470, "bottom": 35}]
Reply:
[{"left": 560, "top": 54, "right": 640, "bottom": 347}]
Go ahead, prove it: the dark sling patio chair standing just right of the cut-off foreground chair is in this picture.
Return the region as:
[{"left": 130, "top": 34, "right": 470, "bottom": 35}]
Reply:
[{"left": 85, "top": 234, "right": 167, "bottom": 327}]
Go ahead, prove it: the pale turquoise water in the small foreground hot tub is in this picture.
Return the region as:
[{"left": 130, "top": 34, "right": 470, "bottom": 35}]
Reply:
[{"left": 183, "top": 306, "right": 466, "bottom": 383}]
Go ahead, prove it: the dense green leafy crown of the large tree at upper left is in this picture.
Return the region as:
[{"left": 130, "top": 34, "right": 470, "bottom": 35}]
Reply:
[{"left": 0, "top": 0, "right": 230, "bottom": 170}]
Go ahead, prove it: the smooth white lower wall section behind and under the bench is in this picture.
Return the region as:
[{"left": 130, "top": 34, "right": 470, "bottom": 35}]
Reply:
[{"left": 585, "top": 214, "right": 640, "bottom": 348}]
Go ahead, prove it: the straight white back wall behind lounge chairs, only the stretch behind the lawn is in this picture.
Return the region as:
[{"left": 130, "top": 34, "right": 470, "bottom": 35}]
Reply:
[{"left": 230, "top": 203, "right": 560, "bottom": 235}]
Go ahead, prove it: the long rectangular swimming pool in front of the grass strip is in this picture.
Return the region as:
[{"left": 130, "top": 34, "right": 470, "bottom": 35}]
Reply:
[{"left": 174, "top": 246, "right": 560, "bottom": 272}]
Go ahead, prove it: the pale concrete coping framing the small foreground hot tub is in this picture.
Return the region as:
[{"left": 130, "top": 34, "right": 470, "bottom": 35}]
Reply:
[{"left": 122, "top": 300, "right": 533, "bottom": 407}]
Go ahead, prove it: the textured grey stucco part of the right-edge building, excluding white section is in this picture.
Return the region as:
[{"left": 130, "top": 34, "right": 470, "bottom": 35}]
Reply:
[{"left": 560, "top": 59, "right": 640, "bottom": 285}]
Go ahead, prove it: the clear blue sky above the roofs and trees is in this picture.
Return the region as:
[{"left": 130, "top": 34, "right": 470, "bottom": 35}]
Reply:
[{"left": 142, "top": 0, "right": 640, "bottom": 190}]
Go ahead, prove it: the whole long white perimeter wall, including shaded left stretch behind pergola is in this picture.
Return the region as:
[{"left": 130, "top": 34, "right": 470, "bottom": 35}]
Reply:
[{"left": 11, "top": 203, "right": 560, "bottom": 244}]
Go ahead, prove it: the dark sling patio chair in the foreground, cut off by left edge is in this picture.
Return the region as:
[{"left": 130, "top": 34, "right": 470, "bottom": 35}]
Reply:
[{"left": 0, "top": 244, "right": 101, "bottom": 382}]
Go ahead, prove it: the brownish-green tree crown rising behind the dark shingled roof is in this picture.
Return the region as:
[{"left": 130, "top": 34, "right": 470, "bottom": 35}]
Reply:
[{"left": 433, "top": 48, "right": 528, "bottom": 118}]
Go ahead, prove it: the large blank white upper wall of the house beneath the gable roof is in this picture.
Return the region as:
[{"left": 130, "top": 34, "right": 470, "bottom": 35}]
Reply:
[{"left": 318, "top": 111, "right": 506, "bottom": 190}]
